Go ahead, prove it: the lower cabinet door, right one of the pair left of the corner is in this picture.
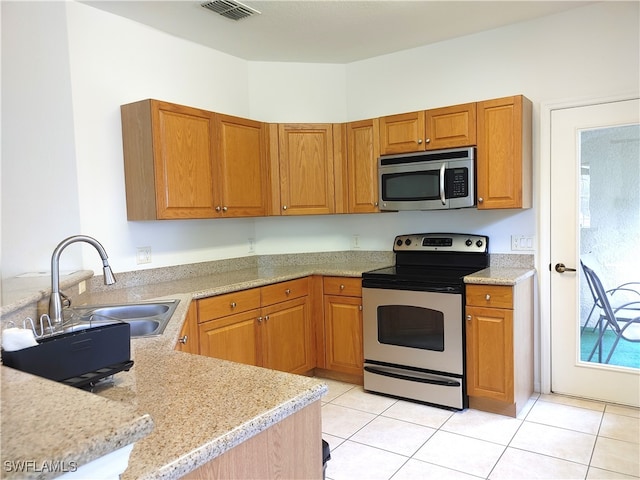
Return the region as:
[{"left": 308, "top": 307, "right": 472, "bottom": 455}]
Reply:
[{"left": 260, "top": 297, "right": 315, "bottom": 373}]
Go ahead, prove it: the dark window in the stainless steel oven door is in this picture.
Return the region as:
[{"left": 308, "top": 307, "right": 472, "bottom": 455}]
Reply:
[{"left": 378, "top": 305, "right": 444, "bottom": 352}]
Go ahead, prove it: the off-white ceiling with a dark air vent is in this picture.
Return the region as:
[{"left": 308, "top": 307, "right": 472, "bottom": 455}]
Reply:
[{"left": 82, "top": 0, "right": 593, "bottom": 63}]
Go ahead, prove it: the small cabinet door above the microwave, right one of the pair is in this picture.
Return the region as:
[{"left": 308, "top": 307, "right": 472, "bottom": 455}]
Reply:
[{"left": 425, "top": 103, "right": 476, "bottom": 150}]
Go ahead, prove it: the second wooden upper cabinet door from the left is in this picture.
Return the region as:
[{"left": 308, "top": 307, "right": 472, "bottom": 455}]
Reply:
[{"left": 216, "top": 114, "right": 269, "bottom": 217}]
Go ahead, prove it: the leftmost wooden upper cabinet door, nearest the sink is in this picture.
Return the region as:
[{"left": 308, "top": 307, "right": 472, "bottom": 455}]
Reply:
[{"left": 152, "top": 101, "right": 216, "bottom": 219}]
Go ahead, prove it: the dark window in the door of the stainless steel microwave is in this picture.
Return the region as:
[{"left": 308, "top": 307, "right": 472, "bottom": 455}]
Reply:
[{"left": 382, "top": 170, "right": 440, "bottom": 201}]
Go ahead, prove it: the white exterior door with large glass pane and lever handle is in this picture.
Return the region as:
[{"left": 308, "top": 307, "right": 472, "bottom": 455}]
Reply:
[{"left": 550, "top": 99, "right": 640, "bottom": 406}]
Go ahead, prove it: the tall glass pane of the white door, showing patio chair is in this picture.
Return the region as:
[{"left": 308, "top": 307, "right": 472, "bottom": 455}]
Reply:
[{"left": 578, "top": 124, "right": 640, "bottom": 368}]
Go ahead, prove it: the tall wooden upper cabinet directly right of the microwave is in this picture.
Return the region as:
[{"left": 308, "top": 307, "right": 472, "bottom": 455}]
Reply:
[{"left": 477, "top": 95, "right": 532, "bottom": 209}]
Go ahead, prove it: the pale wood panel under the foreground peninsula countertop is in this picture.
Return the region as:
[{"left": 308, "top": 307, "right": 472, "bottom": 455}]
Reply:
[{"left": 182, "top": 400, "right": 323, "bottom": 480}]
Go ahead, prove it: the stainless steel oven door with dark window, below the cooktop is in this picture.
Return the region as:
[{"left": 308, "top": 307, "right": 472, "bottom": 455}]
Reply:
[{"left": 362, "top": 288, "right": 464, "bottom": 376}]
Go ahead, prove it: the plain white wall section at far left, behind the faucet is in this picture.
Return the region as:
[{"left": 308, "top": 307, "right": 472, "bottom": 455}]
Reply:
[{"left": 0, "top": 2, "right": 81, "bottom": 278}]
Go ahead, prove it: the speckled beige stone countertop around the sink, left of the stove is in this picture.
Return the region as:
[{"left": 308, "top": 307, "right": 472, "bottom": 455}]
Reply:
[{"left": 2, "top": 256, "right": 388, "bottom": 480}]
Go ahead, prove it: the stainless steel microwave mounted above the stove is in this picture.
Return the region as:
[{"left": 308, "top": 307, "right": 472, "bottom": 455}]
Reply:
[{"left": 378, "top": 147, "right": 476, "bottom": 211}]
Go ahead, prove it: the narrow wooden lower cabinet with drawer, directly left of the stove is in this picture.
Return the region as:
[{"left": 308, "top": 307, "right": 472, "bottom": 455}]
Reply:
[{"left": 323, "top": 277, "right": 364, "bottom": 380}]
